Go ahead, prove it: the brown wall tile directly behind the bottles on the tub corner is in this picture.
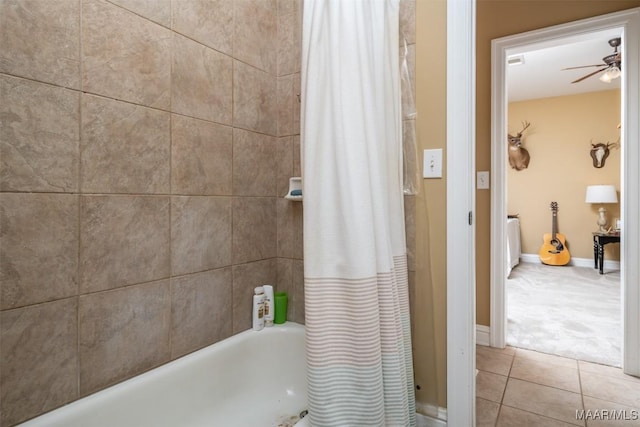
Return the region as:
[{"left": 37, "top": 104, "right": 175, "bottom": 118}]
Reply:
[{"left": 233, "top": 258, "right": 277, "bottom": 334}]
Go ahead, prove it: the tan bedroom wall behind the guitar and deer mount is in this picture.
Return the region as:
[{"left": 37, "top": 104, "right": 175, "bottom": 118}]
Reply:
[{"left": 505, "top": 90, "right": 621, "bottom": 260}]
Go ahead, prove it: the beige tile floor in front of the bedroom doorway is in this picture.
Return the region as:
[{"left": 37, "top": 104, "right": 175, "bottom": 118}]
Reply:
[{"left": 476, "top": 346, "right": 640, "bottom": 427}]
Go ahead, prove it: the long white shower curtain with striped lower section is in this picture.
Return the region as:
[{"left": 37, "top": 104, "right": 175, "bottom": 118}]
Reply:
[{"left": 301, "top": 0, "right": 415, "bottom": 427}]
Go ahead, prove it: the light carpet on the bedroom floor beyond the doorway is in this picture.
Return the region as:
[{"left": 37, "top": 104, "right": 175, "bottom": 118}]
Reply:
[{"left": 506, "top": 263, "right": 622, "bottom": 366}]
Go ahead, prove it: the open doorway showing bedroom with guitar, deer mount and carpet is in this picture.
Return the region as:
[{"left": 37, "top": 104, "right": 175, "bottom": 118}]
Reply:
[{"left": 505, "top": 28, "right": 622, "bottom": 367}]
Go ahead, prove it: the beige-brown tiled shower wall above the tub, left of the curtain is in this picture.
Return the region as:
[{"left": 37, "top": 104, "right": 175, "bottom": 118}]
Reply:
[{"left": 0, "top": 0, "right": 304, "bottom": 426}]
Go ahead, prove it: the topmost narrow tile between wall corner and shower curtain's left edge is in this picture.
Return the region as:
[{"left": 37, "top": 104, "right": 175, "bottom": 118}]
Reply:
[{"left": 277, "top": 0, "right": 302, "bottom": 76}]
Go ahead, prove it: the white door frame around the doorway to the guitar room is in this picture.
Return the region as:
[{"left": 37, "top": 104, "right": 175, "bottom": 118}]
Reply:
[{"left": 490, "top": 8, "right": 640, "bottom": 375}]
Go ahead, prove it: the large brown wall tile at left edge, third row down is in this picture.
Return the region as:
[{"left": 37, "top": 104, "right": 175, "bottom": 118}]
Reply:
[{"left": 0, "top": 193, "right": 78, "bottom": 309}]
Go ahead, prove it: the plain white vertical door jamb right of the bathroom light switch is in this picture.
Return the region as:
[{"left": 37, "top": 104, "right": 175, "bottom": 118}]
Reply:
[{"left": 446, "top": 0, "right": 476, "bottom": 427}]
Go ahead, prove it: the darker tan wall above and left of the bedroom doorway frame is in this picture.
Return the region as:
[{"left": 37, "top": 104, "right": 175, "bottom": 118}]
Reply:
[{"left": 472, "top": 0, "right": 640, "bottom": 325}]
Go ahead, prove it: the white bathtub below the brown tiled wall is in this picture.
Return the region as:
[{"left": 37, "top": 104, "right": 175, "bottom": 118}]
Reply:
[{"left": 21, "top": 322, "right": 308, "bottom": 427}]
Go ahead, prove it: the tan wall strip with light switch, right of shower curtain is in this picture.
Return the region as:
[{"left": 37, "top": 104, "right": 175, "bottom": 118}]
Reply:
[{"left": 412, "top": 0, "right": 447, "bottom": 407}]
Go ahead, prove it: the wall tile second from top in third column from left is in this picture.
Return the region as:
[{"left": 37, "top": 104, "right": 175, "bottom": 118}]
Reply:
[{"left": 171, "top": 34, "right": 233, "bottom": 124}]
